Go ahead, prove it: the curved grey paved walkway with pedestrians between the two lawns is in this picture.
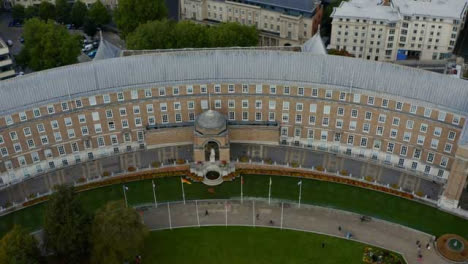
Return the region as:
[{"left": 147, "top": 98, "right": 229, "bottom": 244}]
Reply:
[{"left": 144, "top": 199, "right": 447, "bottom": 264}]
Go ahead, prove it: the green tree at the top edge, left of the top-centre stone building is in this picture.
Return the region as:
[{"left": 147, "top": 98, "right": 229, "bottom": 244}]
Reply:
[{"left": 114, "top": 0, "right": 167, "bottom": 37}]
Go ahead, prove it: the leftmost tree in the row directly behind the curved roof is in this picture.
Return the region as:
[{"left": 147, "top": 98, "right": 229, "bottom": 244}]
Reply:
[{"left": 127, "top": 20, "right": 177, "bottom": 49}]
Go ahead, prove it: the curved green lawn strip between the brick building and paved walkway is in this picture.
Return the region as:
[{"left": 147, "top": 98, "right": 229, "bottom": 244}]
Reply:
[{"left": 0, "top": 175, "right": 468, "bottom": 238}]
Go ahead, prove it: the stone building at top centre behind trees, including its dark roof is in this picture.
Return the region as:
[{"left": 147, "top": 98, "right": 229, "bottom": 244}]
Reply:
[{"left": 180, "top": 0, "right": 323, "bottom": 46}]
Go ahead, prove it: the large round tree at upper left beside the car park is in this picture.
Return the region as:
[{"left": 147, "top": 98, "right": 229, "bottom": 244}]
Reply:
[{"left": 17, "top": 18, "right": 80, "bottom": 71}]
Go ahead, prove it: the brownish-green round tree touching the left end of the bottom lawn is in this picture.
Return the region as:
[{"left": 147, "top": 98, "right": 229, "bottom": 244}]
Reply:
[{"left": 91, "top": 201, "right": 148, "bottom": 264}]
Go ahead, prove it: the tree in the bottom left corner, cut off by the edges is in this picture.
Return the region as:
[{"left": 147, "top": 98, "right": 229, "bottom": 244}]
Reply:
[{"left": 0, "top": 226, "right": 41, "bottom": 264}]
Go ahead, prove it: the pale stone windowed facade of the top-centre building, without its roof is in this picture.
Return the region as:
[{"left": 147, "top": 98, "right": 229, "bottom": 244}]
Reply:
[{"left": 180, "top": 0, "right": 321, "bottom": 46}]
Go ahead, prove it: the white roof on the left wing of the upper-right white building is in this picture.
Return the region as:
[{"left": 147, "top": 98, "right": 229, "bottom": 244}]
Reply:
[{"left": 332, "top": 0, "right": 400, "bottom": 21}]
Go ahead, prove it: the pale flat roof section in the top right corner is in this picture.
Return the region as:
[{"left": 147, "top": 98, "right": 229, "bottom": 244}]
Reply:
[{"left": 392, "top": 0, "right": 468, "bottom": 19}]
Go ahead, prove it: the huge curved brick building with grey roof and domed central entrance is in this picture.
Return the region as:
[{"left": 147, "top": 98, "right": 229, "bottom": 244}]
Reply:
[{"left": 0, "top": 49, "right": 468, "bottom": 208}]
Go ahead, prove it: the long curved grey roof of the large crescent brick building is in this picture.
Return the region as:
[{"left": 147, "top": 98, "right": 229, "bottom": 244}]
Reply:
[{"left": 0, "top": 49, "right": 468, "bottom": 116}]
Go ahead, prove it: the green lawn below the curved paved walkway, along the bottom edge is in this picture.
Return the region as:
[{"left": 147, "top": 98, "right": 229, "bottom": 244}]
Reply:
[{"left": 142, "top": 227, "right": 402, "bottom": 264}]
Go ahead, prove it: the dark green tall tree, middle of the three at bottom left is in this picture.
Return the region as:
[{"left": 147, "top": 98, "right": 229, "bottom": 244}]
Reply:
[{"left": 44, "top": 185, "right": 91, "bottom": 263}]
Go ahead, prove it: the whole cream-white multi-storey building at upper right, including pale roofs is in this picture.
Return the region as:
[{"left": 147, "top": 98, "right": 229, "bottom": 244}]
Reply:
[{"left": 329, "top": 0, "right": 468, "bottom": 61}]
